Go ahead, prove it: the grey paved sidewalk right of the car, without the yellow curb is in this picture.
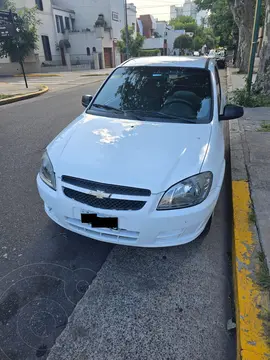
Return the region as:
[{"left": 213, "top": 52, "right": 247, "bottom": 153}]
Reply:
[{"left": 228, "top": 68, "right": 270, "bottom": 267}]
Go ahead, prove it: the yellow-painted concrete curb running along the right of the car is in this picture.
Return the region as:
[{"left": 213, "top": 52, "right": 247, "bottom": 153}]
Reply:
[{"left": 227, "top": 68, "right": 270, "bottom": 360}]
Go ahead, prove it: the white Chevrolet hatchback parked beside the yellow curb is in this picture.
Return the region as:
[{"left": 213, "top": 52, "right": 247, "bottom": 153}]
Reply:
[{"left": 37, "top": 56, "right": 243, "bottom": 247}]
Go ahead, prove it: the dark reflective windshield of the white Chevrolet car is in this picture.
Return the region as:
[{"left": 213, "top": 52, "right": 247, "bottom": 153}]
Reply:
[{"left": 87, "top": 66, "right": 212, "bottom": 123}]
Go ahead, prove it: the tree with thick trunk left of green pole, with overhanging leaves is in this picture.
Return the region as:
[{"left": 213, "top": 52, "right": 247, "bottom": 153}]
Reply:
[{"left": 195, "top": 0, "right": 255, "bottom": 72}]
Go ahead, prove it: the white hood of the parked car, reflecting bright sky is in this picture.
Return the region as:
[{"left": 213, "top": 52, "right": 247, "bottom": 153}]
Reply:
[{"left": 48, "top": 114, "right": 211, "bottom": 193}]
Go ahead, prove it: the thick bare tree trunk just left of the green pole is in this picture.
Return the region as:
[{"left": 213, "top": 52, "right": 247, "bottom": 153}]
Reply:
[{"left": 230, "top": 0, "right": 255, "bottom": 73}]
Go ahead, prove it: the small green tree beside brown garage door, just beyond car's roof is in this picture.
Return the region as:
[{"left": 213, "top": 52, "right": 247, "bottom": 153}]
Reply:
[{"left": 117, "top": 27, "right": 144, "bottom": 57}]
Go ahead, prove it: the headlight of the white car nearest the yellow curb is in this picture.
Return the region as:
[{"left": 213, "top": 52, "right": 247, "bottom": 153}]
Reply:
[{"left": 157, "top": 171, "right": 213, "bottom": 210}]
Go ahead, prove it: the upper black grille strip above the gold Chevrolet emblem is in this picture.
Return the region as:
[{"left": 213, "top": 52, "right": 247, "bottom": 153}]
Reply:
[{"left": 62, "top": 175, "right": 151, "bottom": 196}]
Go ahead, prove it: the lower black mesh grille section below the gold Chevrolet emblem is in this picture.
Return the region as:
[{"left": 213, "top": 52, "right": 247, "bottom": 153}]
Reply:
[{"left": 63, "top": 187, "right": 145, "bottom": 210}]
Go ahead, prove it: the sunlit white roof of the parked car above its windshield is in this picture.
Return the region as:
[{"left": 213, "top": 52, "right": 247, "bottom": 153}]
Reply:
[{"left": 120, "top": 56, "right": 209, "bottom": 69}]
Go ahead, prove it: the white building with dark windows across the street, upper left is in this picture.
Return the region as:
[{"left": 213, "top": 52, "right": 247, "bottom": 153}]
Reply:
[{"left": 1, "top": 0, "right": 127, "bottom": 71}]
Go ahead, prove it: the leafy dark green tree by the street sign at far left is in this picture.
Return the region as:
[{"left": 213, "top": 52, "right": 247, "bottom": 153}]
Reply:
[{"left": 0, "top": 1, "right": 40, "bottom": 63}]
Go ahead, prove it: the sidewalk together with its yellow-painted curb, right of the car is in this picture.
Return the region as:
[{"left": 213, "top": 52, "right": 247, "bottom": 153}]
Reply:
[{"left": 227, "top": 68, "right": 270, "bottom": 360}]
